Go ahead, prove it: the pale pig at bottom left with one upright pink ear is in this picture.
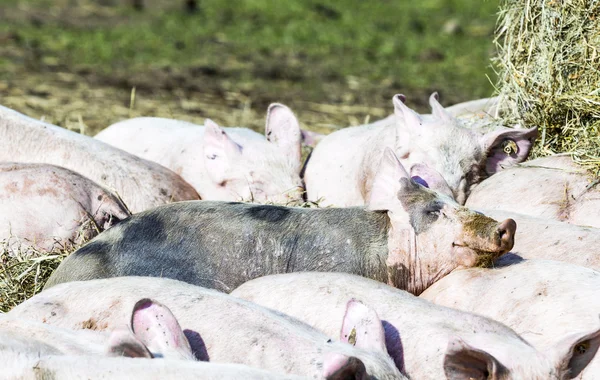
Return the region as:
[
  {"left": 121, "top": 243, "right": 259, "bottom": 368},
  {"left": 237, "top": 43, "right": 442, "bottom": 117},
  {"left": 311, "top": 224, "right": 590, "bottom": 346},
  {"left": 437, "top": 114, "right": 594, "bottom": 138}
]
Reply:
[{"left": 0, "top": 298, "right": 195, "bottom": 360}]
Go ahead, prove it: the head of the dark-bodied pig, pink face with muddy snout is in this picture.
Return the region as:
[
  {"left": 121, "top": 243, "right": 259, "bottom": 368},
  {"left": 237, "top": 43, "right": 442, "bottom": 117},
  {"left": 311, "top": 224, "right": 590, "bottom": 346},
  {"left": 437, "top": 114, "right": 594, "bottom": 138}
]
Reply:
[{"left": 368, "top": 148, "right": 516, "bottom": 295}]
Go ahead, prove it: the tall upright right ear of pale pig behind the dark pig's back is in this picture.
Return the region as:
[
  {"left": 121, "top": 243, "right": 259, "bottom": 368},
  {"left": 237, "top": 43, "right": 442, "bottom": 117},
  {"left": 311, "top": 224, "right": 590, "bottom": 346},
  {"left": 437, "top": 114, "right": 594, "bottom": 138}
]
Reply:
[{"left": 265, "top": 103, "right": 302, "bottom": 166}]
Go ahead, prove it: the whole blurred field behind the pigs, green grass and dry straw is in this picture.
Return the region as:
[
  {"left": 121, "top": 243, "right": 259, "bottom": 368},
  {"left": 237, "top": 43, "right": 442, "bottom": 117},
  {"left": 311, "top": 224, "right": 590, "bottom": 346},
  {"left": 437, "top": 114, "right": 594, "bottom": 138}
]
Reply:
[{"left": 0, "top": 0, "right": 498, "bottom": 134}]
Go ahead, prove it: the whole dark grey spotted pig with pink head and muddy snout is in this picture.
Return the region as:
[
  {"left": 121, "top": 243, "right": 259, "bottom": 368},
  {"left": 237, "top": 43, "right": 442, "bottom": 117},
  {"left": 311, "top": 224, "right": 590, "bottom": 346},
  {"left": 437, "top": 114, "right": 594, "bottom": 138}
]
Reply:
[{"left": 46, "top": 149, "right": 516, "bottom": 294}]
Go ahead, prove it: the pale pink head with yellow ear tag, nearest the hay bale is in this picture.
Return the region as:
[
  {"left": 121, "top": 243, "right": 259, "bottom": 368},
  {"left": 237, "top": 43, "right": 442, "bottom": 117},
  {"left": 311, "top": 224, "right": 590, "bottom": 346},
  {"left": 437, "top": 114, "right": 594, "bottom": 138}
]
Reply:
[{"left": 393, "top": 93, "right": 537, "bottom": 204}]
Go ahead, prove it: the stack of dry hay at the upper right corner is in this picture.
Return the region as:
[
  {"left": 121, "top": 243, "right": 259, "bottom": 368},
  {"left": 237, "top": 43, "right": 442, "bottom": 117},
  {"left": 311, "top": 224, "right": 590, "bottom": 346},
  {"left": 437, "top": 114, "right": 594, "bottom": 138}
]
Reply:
[{"left": 495, "top": 0, "right": 600, "bottom": 174}]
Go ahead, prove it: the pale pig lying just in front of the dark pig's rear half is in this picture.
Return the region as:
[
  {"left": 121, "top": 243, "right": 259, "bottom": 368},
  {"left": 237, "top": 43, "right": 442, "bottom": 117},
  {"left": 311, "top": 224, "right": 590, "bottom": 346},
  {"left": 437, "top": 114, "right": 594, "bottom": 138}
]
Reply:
[{"left": 8, "top": 277, "right": 403, "bottom": 379}]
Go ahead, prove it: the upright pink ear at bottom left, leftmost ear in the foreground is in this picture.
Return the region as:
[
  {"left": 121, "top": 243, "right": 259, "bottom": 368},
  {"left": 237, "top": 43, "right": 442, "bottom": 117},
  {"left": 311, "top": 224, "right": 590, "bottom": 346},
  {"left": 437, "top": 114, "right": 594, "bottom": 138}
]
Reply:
[{"left": 131, "top": 298, "right": 194, "bottom": 359}]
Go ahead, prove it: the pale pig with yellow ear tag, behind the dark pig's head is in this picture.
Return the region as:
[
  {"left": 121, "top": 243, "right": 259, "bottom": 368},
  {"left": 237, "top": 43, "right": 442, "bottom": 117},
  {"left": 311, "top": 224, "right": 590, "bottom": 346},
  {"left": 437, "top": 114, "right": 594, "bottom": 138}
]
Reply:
[{"left": 304, "top": 93, "right": 537, "bottom": 207}]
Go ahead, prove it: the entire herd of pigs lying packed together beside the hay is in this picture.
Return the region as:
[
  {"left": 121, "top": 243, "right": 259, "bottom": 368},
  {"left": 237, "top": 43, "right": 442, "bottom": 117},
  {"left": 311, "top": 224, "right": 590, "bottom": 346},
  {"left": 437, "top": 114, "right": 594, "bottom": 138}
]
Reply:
[{"left": 0, "top": 93, "right": 600, "bottom": 380}]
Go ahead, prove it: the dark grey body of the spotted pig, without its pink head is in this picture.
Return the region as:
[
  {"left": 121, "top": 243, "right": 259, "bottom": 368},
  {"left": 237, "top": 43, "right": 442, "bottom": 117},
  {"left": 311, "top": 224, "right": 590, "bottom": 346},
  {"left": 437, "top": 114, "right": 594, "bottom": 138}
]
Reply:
[{"left": 46, "top": 201, "right": 389, "bottom": 292}]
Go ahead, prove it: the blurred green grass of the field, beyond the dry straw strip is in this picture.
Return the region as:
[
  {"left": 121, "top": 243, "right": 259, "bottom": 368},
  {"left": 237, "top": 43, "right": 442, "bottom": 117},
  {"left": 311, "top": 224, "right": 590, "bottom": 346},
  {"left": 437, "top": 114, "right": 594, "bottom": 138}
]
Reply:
[{"left": 0, "top": 0, "right": 498, "bottom": 110}]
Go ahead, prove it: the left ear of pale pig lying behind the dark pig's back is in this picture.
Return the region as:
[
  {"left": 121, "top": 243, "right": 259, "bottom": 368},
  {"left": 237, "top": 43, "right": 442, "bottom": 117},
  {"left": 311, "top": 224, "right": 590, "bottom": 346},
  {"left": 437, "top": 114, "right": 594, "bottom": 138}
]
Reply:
[{"left": 202, "top": 119, "right": 242, "bottom": 183}]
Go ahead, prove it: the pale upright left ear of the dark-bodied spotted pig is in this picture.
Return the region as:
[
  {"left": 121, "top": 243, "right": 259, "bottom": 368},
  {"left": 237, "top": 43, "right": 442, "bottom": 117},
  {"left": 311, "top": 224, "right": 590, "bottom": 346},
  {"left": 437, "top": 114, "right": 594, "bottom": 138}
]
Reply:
[{"left": 367, "top": 148, "right": 410, "bottom": 211}]
